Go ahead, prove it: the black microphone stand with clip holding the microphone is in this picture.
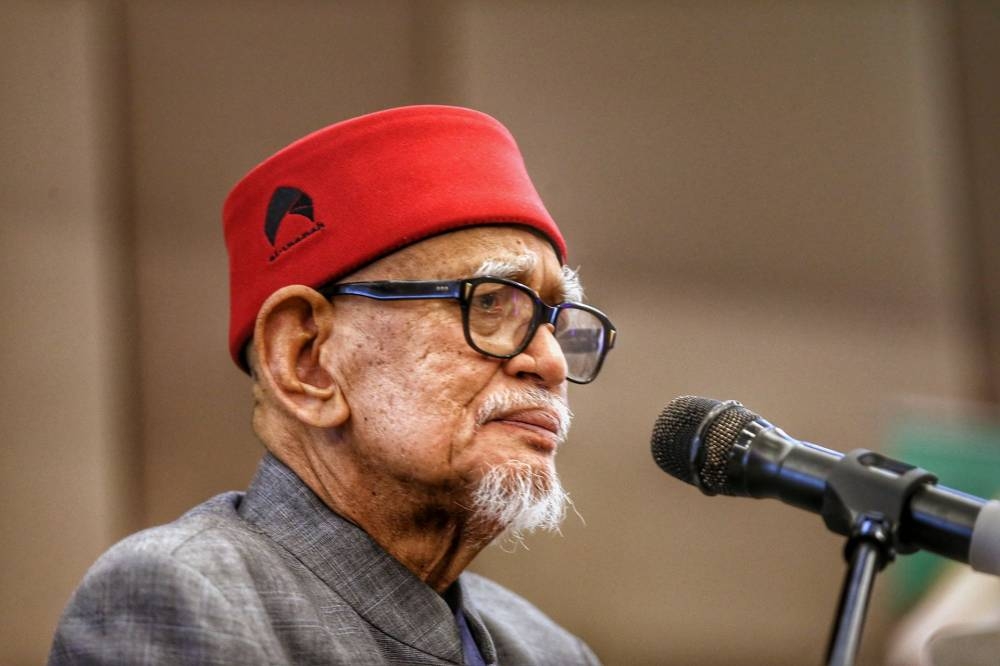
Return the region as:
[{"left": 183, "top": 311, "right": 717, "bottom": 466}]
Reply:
[{"left": 820, "top": 449, "right": 937, "bottom": 666}]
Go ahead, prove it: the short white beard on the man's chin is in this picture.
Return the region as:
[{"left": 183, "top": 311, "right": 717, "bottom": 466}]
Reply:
[{"left": 472, "top": 460, "right": 573, "bottom": 548}]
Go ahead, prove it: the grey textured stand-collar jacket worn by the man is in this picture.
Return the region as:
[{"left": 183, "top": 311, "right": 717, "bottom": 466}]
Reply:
[{"left": 48, "top": 456, "right": 598, "bottom": 666}]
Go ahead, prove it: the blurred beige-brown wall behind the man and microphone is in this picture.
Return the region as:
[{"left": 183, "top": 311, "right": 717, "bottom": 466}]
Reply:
[{"left": 0, "top": 0, "right": 1000, "bottom": 665}]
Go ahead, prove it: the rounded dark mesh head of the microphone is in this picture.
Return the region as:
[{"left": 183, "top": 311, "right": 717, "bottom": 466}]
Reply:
[{"left": 651, "top": 395, "right": 760, "bottom": 495}]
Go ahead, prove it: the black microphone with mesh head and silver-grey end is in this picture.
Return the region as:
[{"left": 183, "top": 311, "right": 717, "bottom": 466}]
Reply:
[{"left": 651, "top": 396, "right": 1000, "bottom": 574}]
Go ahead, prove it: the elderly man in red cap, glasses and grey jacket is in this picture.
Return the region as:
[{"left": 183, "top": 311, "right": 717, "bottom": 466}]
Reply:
[{"left": 50, "top": 106, "right": 615, "bottom": 664}]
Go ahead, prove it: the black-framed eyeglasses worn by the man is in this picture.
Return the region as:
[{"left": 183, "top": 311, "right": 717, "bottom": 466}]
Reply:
[{"left": 319, "top": 276, "right": 618, "bottom": 384}]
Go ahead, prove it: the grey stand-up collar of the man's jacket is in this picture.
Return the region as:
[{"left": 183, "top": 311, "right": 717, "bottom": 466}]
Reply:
[{"left": 239, "top": 455, "right": 497, "bottom": 663}]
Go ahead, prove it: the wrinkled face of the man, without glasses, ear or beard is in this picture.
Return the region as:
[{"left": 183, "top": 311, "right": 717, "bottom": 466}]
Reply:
[{"left": 323, "top": 227, "right": 567, "bottom": 500}]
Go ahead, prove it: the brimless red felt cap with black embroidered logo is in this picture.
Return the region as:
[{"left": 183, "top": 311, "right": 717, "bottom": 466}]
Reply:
[{"left": 222, "top": 106, "right": 566, "bottom": 370}]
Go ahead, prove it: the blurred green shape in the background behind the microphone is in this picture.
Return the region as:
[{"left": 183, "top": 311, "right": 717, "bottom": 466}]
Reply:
[{"left": 886, "top": 418, "right": 1000, "bottom": 612}]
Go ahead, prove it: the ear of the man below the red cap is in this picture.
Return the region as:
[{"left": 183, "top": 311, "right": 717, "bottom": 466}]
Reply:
[{"left": 252, "top": 284, "right": 350, "bottom": 428}]
